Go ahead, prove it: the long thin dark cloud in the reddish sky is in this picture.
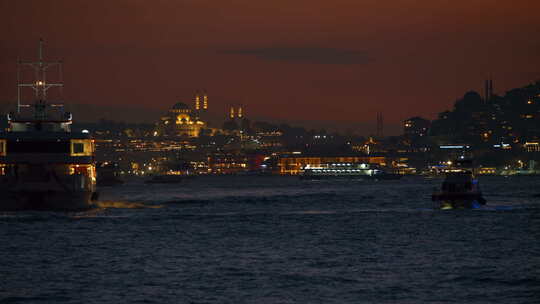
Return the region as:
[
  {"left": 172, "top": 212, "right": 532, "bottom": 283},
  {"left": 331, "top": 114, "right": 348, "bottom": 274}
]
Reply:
[{"left": 222, "top": 47, "right": 370, "bottom": 64}]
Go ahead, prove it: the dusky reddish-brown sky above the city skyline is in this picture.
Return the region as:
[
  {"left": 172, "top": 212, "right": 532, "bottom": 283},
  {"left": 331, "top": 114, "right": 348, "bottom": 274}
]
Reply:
[{"left": 0, "top": 0, "right": 540, "bottom": 133}]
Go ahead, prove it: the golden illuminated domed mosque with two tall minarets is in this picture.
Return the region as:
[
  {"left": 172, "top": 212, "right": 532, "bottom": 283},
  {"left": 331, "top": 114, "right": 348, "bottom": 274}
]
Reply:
[{"left": 154, "top": 92, "right": 208, "bottom": 137}]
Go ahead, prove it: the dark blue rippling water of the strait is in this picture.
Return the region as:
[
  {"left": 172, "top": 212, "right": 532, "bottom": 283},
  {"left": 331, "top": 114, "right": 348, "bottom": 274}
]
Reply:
[{"left": 0, "top": 177, "right": 540, "bottom": 303}]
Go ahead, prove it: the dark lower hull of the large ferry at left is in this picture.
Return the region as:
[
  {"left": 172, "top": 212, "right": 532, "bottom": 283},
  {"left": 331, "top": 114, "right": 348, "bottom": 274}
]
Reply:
[{"left": 0, "top": 191, "right": 95, "bottom": 211}]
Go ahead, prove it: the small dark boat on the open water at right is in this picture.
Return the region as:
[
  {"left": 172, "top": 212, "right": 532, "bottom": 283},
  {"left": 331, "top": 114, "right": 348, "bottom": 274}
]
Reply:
[{"left": 431, "top": 158, "right": 486, "bottom": 210}]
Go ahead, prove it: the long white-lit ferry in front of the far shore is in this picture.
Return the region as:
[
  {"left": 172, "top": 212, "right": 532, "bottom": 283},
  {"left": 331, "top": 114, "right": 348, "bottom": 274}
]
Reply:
[{"left": 300, "top": 163, "right": 402, "bottom": 180}]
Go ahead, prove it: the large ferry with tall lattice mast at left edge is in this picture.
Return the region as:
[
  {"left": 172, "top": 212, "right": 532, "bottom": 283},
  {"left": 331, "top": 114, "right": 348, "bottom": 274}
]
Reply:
[{"left": 0, "top": 40, "right": 97, "bottom": 211}]
